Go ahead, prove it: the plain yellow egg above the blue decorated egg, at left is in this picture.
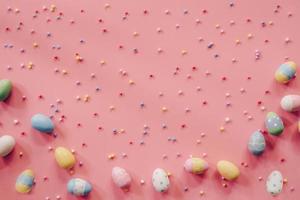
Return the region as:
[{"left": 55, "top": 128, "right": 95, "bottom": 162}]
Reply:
[{"left": 54, "top": 147, "right": 76, "bottom": 169}]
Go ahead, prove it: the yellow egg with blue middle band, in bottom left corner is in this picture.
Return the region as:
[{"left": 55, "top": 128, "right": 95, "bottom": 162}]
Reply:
[{"left": 16, "top": 169, "right": 34, "bottom": 193}]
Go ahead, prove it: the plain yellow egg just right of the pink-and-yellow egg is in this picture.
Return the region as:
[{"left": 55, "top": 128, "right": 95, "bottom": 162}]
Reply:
[{"left": 217, "top": 160, "right": 240, "bottom": 181}]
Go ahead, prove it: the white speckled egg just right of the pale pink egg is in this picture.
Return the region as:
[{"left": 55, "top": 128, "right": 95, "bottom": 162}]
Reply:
[{"left": 152, "top": 168, "right": 170, "bottom": 192}]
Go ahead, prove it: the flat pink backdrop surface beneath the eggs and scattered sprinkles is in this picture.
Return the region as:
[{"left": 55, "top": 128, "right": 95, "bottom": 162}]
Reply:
[{"left": 0, "top": 0, "right": 300, "bottom": 200}]
